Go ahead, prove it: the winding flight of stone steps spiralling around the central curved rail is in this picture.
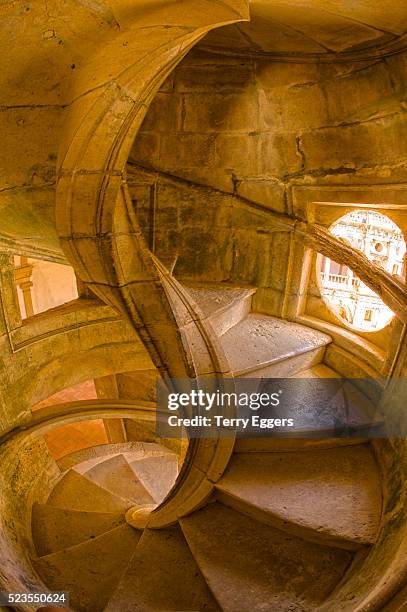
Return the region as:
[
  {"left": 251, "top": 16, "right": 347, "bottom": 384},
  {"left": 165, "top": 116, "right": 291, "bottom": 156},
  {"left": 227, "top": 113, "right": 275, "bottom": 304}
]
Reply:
[{"left": 32, "top": 285, "right": 382, "bottom": 612}]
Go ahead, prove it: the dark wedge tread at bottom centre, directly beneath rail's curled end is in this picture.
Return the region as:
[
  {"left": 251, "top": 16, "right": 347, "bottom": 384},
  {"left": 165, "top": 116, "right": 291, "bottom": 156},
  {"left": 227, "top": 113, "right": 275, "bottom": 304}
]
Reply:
[{"left": 106, "top": 525, "right": 220, "bottom": 612}]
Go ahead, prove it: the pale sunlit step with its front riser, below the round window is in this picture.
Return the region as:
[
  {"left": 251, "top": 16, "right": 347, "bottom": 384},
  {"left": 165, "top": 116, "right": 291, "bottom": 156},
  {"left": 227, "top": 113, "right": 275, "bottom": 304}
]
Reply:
[{"left": 221, "top": 314, "right": 331, "bottom": 378}]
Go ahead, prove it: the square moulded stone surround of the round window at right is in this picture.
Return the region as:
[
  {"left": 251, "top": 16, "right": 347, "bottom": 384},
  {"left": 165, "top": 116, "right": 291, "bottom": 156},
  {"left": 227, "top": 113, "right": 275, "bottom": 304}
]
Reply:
[{"left": 288, "top": 185, "right": 407, "bottom": 373}]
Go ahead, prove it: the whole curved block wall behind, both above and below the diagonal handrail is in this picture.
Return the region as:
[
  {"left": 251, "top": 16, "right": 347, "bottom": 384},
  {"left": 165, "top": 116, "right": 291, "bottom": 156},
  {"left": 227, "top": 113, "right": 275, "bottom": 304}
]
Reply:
[{"left": 129, "top": 49, "right": 407, "bottom": 352}]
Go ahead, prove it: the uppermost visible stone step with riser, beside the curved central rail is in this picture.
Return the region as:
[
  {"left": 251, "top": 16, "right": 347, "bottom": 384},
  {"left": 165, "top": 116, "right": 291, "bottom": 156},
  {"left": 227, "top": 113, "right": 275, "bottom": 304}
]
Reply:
[{"left": 185, "top": 283, "right": 256, "bottom": 336}]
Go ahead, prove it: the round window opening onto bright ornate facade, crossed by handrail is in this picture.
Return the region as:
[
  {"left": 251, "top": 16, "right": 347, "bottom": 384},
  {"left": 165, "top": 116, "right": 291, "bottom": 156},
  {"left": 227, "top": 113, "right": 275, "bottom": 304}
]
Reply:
[{"left": 317, "top": 210, "right": 406, "bottom": 332}]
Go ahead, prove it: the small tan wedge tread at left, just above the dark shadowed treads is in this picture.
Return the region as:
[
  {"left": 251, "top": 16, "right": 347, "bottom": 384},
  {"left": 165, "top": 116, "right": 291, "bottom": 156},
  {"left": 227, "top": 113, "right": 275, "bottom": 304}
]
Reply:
[{"left": 47, "top": 470, "right": 132, "bottom": 512}]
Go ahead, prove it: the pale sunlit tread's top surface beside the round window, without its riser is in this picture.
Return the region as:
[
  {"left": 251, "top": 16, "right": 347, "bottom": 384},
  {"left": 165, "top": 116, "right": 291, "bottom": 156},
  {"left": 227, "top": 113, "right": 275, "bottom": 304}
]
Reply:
[{"left": 221, "top": 313, "right": 331, "bottom": 377}]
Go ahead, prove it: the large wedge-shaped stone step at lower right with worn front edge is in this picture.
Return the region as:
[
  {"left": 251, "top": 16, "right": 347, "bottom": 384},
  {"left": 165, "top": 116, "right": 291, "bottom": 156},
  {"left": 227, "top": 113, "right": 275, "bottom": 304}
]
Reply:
[{"left": 216, "top": 445, "right": 382, "bottom": 549}]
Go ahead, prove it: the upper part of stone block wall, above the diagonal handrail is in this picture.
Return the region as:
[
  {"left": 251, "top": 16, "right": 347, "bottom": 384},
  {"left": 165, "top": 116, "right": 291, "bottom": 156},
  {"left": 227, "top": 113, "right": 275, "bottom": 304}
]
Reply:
[{"left": 130, "top": 50, "right": 407, "bottom": 211}]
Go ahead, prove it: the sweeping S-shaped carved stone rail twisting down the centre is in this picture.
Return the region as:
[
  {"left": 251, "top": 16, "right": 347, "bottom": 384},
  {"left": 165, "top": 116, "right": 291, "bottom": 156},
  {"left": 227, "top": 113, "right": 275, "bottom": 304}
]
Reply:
[{"left": 56, "top": 0, "right": 248, "bottom": 527}]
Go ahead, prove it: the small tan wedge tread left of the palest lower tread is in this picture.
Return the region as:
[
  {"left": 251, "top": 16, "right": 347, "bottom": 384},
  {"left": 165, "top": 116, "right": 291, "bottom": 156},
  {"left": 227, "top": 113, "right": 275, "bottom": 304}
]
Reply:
[{"left": 84, "top": 455, "right": 154, "bottom": 506}]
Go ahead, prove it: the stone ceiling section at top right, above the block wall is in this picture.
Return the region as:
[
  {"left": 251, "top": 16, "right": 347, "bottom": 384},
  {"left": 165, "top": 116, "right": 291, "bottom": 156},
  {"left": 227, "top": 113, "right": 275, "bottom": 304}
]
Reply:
[{"left": 204, "top": 0, "right": 407, "bottom": 59}]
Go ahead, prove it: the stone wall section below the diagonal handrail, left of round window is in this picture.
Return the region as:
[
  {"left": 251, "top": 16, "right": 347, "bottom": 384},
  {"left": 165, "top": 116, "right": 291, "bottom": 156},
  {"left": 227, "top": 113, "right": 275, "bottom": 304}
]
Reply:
[{"left": 129, "top": 167, "right": 290, "bottom": 315}]
